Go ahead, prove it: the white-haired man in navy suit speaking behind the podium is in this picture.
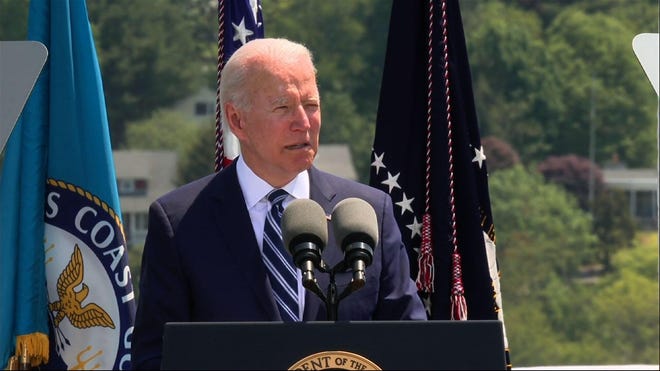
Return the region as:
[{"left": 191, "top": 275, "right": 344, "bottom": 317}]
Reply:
[{"left": 132, "top": 38, "right": 427, "bottom": 369}]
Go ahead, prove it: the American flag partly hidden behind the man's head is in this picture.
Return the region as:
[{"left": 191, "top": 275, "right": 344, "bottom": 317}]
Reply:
[{"left": 215, "top": 0, "right": 264, "bottom": 171}]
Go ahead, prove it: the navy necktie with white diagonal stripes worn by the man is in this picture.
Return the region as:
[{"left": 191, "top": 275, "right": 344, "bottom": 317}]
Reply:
[{"left": 263, "top": 189, "right": 300, "bottom": 322}]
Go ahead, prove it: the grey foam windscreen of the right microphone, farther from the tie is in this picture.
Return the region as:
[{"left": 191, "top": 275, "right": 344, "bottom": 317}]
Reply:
[{"left": 330, "top": 197, "right": 378, "bottom": 249}]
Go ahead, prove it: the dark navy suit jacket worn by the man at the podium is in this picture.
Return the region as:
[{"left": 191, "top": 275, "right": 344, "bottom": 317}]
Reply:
[{"left": 131, "top": 162, "right": 427, "bottom": 368}]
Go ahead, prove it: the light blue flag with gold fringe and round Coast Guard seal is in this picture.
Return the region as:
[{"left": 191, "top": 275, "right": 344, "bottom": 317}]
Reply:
[{"left": 0, "top": 0, "right": 135, "bottom": 369}]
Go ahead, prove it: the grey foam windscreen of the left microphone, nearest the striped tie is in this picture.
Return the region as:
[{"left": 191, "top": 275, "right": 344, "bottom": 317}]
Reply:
[{"left": 282, "top": 198, "right": 328, "bottom": 252}]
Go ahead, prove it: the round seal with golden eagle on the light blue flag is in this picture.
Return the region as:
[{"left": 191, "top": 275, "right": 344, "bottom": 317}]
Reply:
[{"left": 44, "top": 179, "right": 135, "bottom": 370}]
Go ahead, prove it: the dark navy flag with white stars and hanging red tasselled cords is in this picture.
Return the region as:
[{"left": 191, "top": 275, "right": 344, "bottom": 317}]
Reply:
[{"left": 370, "top": 0, "right": 509, "bottom": 370}]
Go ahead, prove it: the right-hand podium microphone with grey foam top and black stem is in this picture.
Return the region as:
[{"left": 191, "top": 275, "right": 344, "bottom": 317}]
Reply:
[{"left": 330, "top": 197, "right": 378, "bottom": 289}]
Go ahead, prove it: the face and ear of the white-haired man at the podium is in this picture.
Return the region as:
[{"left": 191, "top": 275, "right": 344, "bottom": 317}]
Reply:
[{"left": 226, "top": 56, "right": 321, "bottom": 187}]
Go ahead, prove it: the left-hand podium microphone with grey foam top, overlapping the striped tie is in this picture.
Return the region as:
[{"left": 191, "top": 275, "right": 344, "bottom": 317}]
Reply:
[{"left": 281, "top": 199, "right": 328, "bottom": 287}]
